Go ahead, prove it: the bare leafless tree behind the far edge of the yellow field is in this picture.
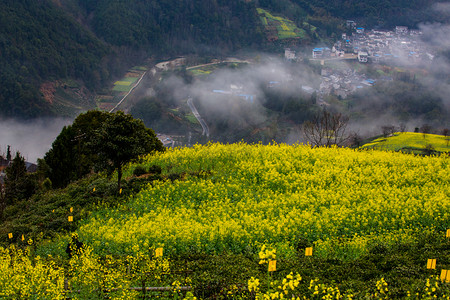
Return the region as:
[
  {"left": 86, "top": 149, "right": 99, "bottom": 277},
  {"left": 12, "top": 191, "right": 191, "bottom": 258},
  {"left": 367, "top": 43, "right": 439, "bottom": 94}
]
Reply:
[{"left": 303, "top": 110, "right": 350, "bottom": 147}]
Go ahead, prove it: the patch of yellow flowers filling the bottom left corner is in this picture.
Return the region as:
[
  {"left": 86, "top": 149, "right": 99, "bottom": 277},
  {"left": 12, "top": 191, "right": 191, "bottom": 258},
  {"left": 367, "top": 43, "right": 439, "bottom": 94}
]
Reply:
[{"left": 0, "top": 245, "right": 176, "bottom": 300}]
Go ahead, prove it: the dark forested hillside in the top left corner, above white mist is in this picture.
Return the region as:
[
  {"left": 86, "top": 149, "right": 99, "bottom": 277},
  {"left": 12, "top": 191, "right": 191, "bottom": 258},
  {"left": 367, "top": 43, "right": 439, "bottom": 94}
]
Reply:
[{"left": 0, "top": 0, "right": 110, "bottom": 117}]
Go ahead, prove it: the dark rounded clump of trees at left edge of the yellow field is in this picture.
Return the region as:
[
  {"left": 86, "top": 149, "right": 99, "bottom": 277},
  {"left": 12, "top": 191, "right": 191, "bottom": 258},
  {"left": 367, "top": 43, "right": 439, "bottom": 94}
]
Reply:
[{"left": 44, "top": 111, "right": 165, "bottom": 187}]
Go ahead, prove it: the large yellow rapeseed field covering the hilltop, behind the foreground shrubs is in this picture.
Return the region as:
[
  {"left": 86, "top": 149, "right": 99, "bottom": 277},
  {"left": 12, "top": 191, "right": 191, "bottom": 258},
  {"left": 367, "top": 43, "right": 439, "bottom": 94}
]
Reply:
[{"left": 71, "top": 143, "right": 450, "bottom": 258}]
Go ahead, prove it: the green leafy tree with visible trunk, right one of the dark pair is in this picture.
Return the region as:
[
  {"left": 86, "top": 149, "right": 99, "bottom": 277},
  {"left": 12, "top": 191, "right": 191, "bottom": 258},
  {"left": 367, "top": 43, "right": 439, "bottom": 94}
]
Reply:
[{"left": 90, "top": 111, "right": 165, "bottom": 190}]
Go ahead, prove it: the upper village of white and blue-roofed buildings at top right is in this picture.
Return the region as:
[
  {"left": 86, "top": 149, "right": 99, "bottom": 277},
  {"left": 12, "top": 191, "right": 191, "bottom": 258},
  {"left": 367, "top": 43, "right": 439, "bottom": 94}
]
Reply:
[{"left": 312, "top": 21, "right": 434, "bottom": 63}]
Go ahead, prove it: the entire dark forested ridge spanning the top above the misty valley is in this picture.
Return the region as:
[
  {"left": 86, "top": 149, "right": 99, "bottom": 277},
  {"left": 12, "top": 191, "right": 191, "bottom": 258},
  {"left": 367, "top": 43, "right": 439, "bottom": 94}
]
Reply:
[{"left": 0, "top": 0, "right": 440, "bottom": 118}]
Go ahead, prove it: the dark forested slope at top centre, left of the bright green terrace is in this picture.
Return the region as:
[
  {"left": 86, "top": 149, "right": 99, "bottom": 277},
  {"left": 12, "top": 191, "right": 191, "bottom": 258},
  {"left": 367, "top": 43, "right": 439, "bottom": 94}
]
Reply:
[{"left": 74, "top": 0, "right": 262, "bottom": 54}]
